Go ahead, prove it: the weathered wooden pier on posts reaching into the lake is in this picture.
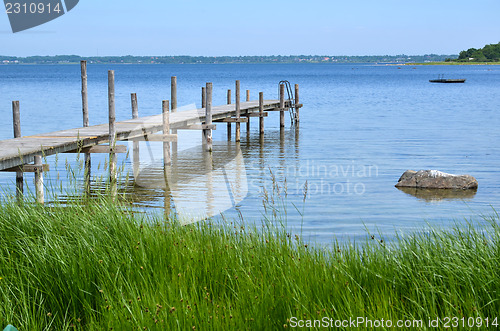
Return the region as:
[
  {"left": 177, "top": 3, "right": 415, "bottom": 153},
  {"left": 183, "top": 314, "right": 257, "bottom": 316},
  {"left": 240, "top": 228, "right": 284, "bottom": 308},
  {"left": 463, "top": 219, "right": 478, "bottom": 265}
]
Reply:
[{"left": 0, "top": 61, "right": 302, "bottom": 203}]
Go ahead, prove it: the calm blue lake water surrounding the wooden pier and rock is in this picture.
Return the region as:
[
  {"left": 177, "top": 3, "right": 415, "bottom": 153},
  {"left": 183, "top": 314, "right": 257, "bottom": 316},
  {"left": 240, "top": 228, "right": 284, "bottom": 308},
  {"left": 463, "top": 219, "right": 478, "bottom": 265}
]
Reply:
[{"left": 0, "top": 64, "right": 500, "bottom": 244}]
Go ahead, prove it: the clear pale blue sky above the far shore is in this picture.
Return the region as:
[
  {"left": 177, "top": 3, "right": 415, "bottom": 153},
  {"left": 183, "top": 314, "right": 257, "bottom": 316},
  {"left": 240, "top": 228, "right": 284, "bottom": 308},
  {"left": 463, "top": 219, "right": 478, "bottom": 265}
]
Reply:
[{"left": 0, "top": 0, "right": 500, "bottom": 56}]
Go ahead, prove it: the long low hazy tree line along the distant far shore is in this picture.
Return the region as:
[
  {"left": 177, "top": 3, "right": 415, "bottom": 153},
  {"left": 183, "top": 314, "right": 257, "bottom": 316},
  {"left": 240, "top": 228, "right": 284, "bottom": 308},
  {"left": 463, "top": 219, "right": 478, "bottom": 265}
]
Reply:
[{"left": 0, "top": 54, "right": 457, "bottom": 64}]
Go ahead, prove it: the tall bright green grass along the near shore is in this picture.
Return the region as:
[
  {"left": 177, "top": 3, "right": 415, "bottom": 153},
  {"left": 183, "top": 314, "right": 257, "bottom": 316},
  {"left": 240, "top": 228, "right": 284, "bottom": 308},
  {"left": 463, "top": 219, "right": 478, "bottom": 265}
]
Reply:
[{"left": 0, "top": 198, "right": 500, "bottom": 330}]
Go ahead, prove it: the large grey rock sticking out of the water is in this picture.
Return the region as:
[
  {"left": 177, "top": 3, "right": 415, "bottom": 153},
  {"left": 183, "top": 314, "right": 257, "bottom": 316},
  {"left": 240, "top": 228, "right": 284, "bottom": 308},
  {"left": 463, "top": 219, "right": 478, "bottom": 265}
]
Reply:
[{"left": 396, "top": 170, "right": 478, "bottom": 190}]
